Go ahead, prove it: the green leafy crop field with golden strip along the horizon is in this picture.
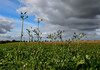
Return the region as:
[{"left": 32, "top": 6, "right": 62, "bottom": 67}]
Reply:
[{"left": 0, "top": 41, "right": 100, "bottom": 70}]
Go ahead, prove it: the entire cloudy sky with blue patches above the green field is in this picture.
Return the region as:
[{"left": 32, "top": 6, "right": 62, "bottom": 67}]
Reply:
[{"left": 0, "top": 0, "right": 100, "bottom": 40}]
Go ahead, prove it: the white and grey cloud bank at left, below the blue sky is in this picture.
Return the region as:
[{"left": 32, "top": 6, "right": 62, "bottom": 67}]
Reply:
[{"left": 0, "top": 16, "right": 37, "bottom": 40}]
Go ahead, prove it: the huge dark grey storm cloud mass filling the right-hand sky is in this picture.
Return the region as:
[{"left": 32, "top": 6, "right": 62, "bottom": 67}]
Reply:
[{"left": 18, "top": 0, "right": 100, "bottom": 38}]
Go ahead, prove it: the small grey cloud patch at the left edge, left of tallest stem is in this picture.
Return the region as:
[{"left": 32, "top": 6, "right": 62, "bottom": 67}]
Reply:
[{"left": 0, "top": 16, "right": 15, "bottom": 34}]
